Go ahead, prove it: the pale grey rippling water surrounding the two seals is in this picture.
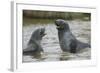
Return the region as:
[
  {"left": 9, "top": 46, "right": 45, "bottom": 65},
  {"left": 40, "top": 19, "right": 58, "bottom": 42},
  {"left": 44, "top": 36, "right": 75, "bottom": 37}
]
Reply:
[{"left": 22, "top": 20, "right": 91, "bottom": 62}]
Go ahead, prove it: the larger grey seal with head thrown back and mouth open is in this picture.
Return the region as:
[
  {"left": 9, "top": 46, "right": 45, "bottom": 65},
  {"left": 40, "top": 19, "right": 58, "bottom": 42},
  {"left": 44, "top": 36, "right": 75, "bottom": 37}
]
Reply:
[{"left": 55, "top": 19, "right": 90, "bottom": 53}]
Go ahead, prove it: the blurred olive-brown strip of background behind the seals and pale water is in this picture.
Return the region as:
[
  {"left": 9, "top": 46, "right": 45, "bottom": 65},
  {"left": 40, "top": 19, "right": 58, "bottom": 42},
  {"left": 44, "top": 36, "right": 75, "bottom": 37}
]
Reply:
[{"left": 23, "top": 10, "right": 91, "bottom": 25}]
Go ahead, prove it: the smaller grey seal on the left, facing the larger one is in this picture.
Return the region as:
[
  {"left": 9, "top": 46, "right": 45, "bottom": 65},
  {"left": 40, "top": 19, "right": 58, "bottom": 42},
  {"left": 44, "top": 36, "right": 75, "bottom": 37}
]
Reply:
[{"left": 23, "top": 28, "right": 45, "bottom": 55}]
